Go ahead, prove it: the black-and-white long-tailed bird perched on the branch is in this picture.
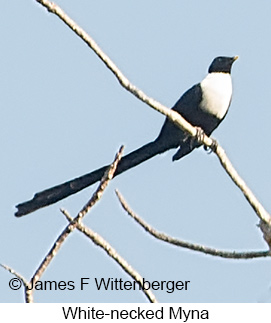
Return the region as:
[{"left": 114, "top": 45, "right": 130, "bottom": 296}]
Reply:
[{"left": 15, "top": 56, "right": 238, "bottom": 217}]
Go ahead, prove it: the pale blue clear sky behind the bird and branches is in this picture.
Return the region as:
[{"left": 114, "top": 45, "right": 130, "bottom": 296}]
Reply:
[{"left": 0, "top": 0, "right": 271, "bottom": 302}]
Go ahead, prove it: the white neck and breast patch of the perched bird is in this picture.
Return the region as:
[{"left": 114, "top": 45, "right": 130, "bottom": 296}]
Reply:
[{"left": 200, "top": 73, "right": 232, "bottom": 120}]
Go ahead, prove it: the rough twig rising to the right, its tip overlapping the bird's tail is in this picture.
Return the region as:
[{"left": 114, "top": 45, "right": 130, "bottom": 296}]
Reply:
[{"left": 26, "top": 147, "right": 123, "bottom": 303}]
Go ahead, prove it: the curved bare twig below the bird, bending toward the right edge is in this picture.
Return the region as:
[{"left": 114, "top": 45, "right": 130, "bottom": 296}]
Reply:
[{"left": 116, "top": 190, "right": 270, "bottom": 259}]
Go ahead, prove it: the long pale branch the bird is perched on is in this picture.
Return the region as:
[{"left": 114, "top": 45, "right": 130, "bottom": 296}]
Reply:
[{"left": 36, "top": 0, "right": 271, "bottom": 233}]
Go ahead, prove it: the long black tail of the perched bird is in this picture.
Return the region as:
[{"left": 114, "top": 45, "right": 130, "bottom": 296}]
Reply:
[{"left": 15, "top": 139, "right": 174, "bottom": 217}]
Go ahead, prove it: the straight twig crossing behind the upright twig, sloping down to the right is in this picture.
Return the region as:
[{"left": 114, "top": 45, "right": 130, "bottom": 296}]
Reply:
[{"left": 61, "top": 209, "right": 157, "bottom": 303}]
